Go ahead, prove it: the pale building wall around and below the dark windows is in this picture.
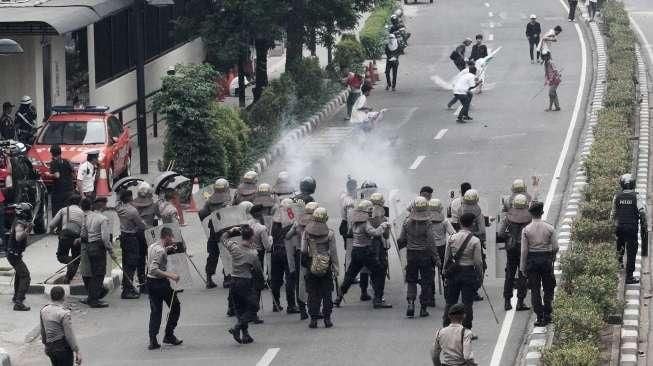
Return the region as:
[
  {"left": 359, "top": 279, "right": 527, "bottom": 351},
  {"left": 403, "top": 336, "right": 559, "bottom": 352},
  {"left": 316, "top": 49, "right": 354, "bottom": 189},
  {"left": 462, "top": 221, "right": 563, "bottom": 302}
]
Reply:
[{"left": 87, "top": 26, "right": 206, "bottom": 120}]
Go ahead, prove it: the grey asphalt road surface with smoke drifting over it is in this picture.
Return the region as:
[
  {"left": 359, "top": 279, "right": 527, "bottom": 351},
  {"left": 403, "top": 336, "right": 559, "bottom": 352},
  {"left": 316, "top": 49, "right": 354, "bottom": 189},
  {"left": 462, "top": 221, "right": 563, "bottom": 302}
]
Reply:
[{"left": 10, "top": 0, "right": 584, "bottom": 366}]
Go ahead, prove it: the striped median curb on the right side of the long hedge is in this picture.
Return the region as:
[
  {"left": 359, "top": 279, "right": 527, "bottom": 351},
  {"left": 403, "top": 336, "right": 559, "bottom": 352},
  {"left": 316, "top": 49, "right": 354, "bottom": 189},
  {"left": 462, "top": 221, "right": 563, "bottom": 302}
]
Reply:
[{"left": 619, "top": 44, "right": 650, "bottom": 366}]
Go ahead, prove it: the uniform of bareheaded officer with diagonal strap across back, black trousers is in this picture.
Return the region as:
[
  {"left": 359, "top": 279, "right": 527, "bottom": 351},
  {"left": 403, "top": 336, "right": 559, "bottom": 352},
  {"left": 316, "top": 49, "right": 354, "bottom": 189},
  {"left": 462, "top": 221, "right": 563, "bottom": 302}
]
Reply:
[{"left": 443, "top": 228, "right": 484, "bottom": 329}]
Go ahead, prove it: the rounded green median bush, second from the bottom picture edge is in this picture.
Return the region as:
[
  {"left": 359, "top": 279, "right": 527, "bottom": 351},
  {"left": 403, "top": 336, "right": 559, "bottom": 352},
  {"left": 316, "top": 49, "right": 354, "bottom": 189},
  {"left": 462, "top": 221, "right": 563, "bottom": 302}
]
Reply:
[{"left": 553, "top": 291, "right": 603, "bottom": 344}]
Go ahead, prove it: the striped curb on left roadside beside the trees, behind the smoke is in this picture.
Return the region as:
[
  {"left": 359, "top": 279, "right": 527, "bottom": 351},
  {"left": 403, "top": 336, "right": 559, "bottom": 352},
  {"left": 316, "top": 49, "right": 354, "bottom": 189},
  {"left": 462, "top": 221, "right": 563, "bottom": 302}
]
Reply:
[{"left": 252, "top": 90, "right": 349, "bottom": 174}]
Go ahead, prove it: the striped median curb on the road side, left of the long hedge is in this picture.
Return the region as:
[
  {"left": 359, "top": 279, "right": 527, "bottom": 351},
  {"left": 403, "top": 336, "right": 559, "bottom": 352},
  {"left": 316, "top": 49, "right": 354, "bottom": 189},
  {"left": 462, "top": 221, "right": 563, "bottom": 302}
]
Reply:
[{"left": 522, "top": 15, "right": 608, "bottom": 366}]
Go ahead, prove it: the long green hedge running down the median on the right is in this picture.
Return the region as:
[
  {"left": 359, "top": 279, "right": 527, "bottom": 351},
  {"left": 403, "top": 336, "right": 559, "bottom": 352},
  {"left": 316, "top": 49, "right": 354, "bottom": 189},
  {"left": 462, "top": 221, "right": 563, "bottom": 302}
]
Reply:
[{"left": 543, "top": 0, "right": 636, "bottom": 366}]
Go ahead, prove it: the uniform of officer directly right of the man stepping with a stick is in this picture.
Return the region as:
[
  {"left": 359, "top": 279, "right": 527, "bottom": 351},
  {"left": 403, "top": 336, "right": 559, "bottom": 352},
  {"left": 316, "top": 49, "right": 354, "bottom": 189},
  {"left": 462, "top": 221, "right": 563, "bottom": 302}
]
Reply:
[{"left": 225, "top": 237, "right": 263, "bottom": 343}]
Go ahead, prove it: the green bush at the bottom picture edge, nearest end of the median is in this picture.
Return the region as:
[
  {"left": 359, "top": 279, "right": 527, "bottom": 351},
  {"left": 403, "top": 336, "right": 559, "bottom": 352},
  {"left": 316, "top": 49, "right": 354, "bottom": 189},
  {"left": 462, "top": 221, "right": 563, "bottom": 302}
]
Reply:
[{"left": 542, "top": 341, "right": 601, "bottom": 366}]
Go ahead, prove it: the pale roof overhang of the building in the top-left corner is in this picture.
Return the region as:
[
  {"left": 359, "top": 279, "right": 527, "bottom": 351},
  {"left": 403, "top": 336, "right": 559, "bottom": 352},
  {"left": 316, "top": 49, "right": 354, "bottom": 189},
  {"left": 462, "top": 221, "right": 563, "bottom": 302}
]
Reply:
[{"left": 0, "top": 0, "right": 134, "bottom": 35}]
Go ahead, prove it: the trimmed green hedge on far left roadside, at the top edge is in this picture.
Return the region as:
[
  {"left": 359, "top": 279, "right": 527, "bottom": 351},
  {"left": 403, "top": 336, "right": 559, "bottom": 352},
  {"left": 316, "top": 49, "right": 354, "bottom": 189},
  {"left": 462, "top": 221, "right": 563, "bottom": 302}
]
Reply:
[{"left": 360, "top": 0, "right": 397, "bottom": 60}]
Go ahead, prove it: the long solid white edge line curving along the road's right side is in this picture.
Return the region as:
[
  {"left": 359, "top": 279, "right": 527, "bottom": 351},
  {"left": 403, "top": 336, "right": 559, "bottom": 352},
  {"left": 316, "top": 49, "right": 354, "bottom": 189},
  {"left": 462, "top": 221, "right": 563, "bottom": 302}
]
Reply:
[{"left": 490, "top": 0, "right": 587, "bottom": 366}]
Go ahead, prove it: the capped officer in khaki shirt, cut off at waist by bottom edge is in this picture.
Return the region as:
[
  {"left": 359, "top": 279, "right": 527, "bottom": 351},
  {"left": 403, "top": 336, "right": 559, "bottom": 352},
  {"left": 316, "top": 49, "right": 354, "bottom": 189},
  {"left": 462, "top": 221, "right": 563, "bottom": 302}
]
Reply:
[{"left": 431, "top": 304, "right": 478, "bottom": 366}]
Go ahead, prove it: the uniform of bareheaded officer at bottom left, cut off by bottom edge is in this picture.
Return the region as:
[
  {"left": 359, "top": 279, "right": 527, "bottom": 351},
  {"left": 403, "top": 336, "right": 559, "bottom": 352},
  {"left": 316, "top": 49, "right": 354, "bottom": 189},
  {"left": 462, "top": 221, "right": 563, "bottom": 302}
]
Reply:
[{"left": 40, "top": 302, "right": 79, "bottom": 366}]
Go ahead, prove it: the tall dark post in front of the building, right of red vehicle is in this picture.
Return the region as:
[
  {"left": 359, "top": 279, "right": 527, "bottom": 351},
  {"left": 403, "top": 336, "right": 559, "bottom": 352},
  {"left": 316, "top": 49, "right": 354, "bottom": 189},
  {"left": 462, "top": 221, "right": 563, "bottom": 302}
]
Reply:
[{"left": 133, "top": 0, "right": 175, "bottom": 174}]
